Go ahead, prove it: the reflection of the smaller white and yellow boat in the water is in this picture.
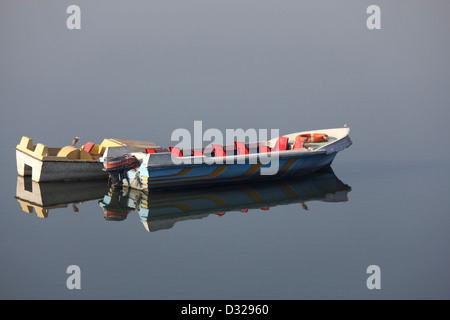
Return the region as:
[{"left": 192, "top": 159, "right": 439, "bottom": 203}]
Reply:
[{"left": 16, "top": 176, "right": 109, "bottom": 218}]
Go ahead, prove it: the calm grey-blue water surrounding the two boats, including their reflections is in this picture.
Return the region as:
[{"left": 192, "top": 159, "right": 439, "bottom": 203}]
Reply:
[{"left": 0, "top": 1, "right": 450, "bottom": 299}]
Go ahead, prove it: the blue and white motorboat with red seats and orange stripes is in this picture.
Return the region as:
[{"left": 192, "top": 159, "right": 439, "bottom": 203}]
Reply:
[{"left": 103, "top": 127, "right": 352, "bottom": 190}]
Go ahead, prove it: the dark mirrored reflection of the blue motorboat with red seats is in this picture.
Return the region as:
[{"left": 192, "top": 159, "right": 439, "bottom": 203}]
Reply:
[{"left": 99, "top": 168, "right": 351, "bottom": 231}]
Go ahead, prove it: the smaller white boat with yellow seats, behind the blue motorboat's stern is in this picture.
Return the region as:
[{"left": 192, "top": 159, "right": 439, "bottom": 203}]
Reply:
[{"left": 16, "top": 136, "right": 159, "bottom": 182}]
